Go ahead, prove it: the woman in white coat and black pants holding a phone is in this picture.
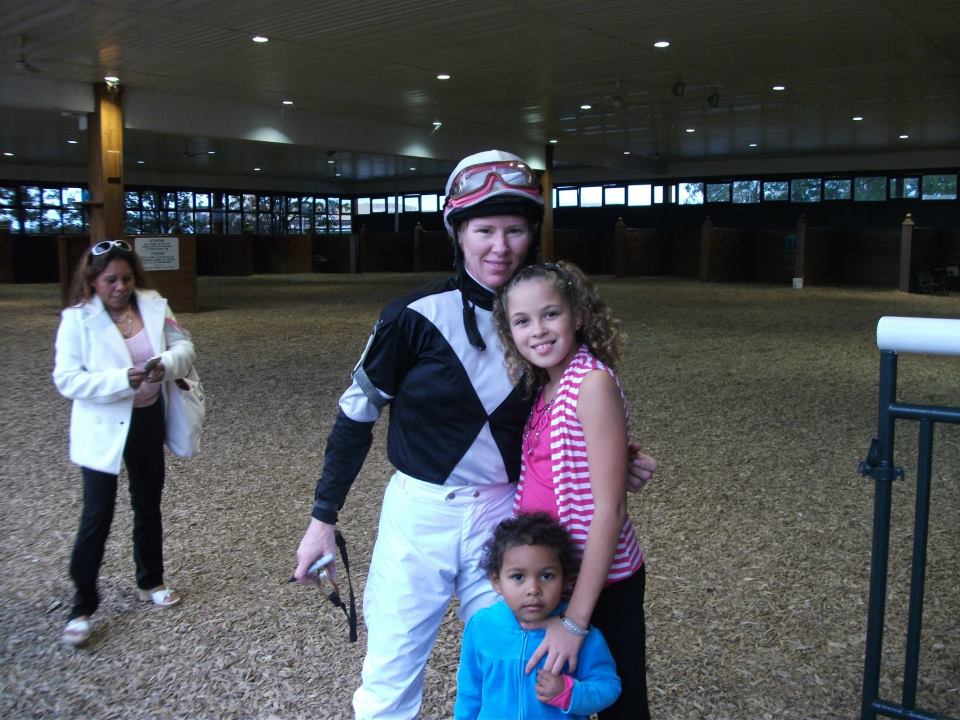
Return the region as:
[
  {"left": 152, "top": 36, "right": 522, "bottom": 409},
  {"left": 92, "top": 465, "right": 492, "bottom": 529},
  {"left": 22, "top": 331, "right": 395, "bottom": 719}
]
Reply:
[{"left": 53, "top": 240, "right": 194, "bottom": 645}]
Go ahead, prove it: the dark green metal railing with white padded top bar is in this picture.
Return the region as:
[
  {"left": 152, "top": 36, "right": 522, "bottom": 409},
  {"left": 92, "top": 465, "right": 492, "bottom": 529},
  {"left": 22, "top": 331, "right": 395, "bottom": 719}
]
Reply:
[{"left": 860, "top": 317, "right": 960, "bottom": 720}]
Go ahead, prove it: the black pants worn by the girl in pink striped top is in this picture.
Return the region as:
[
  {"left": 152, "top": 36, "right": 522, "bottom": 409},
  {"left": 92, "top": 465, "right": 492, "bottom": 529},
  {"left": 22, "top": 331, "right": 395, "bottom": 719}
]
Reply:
[{"left": 590, "top": 565, "right": 650, "bottom": 720}]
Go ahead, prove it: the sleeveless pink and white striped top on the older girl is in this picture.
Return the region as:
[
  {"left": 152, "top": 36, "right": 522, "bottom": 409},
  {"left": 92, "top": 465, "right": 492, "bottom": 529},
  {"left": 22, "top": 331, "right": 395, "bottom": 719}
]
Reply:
[{"left": 513, "top": 346, "right": 643, "bottom": 584}]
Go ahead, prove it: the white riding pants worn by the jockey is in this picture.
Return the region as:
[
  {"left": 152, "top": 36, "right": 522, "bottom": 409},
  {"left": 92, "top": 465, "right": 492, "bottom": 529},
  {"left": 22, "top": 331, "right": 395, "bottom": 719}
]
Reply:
[{"left": 353, "top": 471, "right": 516, "bottom": 720}]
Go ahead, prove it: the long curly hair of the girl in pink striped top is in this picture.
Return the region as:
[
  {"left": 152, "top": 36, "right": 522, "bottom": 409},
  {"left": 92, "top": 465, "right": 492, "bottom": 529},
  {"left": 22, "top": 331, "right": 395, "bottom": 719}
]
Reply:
[{"left": 493, "top": 261, "right": 625, "bottom": 395}]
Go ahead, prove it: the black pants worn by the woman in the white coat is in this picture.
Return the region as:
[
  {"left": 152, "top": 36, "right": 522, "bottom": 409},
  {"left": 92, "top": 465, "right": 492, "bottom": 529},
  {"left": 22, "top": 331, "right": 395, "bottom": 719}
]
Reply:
[{"left": 70, "top": 399, "right": 165, "bottom": 619}]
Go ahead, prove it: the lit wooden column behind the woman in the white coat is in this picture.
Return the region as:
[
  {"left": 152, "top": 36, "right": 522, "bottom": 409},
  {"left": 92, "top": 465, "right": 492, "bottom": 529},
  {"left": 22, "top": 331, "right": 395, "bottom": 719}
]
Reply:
[{"left": 86, "top": 83, "right": 123, "bottom": 245}]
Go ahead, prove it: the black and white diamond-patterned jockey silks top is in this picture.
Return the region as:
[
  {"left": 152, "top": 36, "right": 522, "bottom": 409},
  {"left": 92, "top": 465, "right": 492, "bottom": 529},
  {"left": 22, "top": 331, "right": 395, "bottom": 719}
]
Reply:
[{"left": 312, "top": 272, "right": 531, "bottom": 523}]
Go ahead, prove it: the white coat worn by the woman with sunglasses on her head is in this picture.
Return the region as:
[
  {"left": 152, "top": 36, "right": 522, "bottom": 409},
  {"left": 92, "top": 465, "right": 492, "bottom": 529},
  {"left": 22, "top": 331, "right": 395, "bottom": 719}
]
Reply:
[{"left": 53, "top": 290, "right": 195, "bottom": 475}]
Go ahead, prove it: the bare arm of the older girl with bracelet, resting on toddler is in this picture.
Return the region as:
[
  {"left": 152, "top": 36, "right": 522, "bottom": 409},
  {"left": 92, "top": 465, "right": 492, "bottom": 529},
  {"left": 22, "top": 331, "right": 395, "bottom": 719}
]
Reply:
[{"left": 526, "top": 370, "right": 627, "bottom": 674}]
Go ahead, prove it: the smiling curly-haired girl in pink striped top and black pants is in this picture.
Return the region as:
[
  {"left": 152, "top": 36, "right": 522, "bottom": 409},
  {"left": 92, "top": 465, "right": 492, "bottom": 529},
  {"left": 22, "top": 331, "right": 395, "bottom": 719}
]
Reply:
[{"left": 494, "top": 263, "right": 650, "bottom": 720}]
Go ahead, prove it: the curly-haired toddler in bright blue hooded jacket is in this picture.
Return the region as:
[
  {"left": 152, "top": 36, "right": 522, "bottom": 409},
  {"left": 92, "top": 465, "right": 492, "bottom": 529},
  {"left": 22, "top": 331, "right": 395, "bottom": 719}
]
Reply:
[{"left": 453, "top": 513, "right": 620, "bottom": 720}]
